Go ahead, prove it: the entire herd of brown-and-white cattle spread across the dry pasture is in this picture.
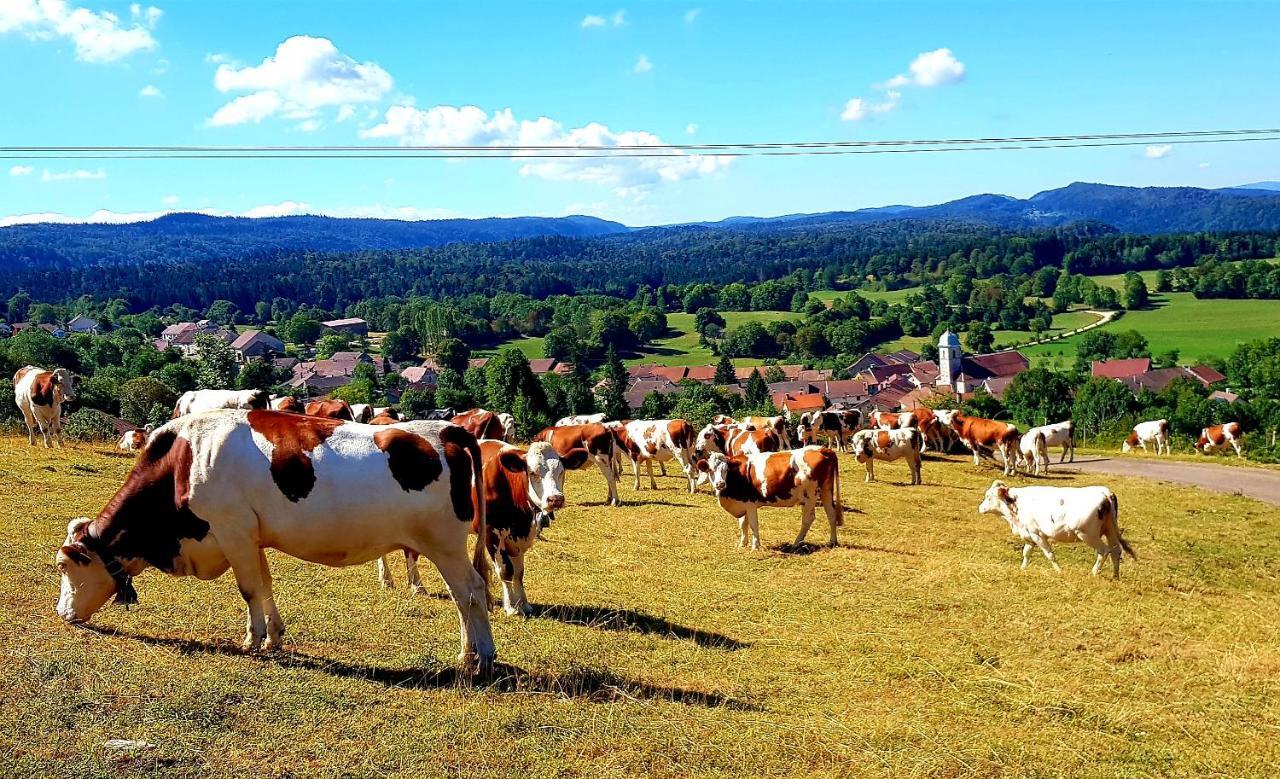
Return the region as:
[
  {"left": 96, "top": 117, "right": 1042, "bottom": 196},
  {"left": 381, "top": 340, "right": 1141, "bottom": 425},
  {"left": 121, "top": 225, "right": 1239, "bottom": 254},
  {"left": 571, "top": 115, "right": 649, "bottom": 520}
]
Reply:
[{"left": 2, "top": 366, "right": 1240, "bottom": 665}]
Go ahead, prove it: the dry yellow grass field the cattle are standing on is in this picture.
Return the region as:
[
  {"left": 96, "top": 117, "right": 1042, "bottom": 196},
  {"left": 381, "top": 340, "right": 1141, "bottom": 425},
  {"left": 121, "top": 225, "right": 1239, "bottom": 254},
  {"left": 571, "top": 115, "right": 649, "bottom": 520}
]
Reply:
[{"left": 0, "top": 436, "right": 1280, "bottom": 778}]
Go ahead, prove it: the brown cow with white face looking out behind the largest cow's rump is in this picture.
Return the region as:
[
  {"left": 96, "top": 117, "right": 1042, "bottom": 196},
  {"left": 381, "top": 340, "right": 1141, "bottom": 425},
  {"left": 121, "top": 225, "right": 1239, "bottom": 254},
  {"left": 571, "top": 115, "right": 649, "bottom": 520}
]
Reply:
[{"left": 378, "top": 441, "right": 588, "bottom": 617}]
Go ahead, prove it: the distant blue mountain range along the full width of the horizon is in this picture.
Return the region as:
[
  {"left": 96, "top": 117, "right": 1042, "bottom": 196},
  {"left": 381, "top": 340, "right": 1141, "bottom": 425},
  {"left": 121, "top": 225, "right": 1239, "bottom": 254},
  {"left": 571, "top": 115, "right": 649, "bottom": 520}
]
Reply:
[{"left": 0, "top": 182, "right": 1280, "bottom": 266}]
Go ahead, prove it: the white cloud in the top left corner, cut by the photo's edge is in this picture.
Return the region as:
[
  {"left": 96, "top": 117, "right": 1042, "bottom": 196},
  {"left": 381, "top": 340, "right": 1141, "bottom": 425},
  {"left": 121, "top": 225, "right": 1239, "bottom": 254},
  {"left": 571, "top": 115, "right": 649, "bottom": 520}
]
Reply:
[{"left": 0, "top": 0, "right": 163, "bottom": 63}]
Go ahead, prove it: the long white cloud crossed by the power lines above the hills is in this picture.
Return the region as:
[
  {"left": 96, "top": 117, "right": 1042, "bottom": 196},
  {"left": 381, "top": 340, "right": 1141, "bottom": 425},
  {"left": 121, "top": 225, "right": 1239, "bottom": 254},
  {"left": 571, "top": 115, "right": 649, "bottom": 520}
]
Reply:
[{"left": 361, "top": 105, "right": 730, "bottom": 197}]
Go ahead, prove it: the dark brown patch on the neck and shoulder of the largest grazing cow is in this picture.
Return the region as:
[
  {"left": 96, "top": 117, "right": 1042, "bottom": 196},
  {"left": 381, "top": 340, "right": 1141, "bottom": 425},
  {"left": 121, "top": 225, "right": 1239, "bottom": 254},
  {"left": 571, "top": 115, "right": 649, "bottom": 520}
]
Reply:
[{"left": 76, "top": 429, "right": 209, "bottom": 572}]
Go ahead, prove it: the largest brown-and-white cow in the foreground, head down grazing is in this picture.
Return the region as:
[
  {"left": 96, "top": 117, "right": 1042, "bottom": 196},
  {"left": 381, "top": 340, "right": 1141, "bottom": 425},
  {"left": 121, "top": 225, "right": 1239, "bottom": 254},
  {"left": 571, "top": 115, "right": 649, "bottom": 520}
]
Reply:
[{"left": 56, "top": 411, "right": 494, "bottom": 670}]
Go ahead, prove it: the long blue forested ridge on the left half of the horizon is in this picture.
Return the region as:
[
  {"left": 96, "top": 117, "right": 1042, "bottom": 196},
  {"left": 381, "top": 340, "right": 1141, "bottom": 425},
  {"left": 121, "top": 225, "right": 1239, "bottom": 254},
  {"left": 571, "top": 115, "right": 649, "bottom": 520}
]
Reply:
[{"left": 0, "top": 214, "right": 628, "bottom": 267}]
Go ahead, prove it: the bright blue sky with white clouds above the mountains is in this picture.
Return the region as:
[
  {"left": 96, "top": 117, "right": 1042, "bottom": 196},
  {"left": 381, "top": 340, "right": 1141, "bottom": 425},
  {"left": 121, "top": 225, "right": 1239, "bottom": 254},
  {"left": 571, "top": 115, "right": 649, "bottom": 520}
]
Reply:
[{"left": 0, "top": 0, "right": 1280, "bottom": 224}]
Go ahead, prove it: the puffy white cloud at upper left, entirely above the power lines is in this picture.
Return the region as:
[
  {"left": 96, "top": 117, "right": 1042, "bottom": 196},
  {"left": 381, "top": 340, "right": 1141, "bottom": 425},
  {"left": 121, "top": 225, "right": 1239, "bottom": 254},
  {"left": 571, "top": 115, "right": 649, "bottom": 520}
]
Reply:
[{"left": 206, "top": 36, "right": 393, "bottom": 127}]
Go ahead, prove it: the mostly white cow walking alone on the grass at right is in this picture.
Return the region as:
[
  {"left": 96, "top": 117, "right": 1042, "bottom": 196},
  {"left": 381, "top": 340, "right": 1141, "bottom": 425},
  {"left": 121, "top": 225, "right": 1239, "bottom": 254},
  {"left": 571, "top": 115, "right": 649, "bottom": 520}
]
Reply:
[{"left": 978, "top": 480, "right": 1138, "bottom": 578}]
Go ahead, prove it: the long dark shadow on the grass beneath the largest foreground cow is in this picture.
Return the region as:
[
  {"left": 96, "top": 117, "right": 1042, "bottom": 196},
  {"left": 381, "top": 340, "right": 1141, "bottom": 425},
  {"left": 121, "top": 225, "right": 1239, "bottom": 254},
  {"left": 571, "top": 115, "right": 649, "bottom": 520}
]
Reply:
[{"left": 84, "top": 626, "right": 759, "bottom": 711}]
